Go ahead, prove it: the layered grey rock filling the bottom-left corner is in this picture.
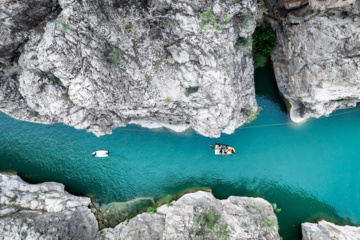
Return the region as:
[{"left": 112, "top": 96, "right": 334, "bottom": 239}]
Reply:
[{"left": 0, "top": 174, "right": 98, "bottom": 240}]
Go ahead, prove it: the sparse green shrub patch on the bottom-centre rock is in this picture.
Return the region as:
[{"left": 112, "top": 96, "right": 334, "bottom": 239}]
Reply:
[{"left": 193, "top": 211, "right": 230, "bottom": 240}]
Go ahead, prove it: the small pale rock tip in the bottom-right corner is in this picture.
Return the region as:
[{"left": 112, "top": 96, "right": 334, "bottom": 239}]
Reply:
[{"left": 301, "top": 221, "right": 360, "bottom": 240}]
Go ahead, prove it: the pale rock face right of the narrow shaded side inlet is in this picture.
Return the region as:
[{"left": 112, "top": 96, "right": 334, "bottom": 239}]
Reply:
[{"left": 267, "top": 0, "right": 360, "bottom": 122}]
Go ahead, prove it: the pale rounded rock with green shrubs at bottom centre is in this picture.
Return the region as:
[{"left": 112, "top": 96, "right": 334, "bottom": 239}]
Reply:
[{"left": 97, "top": 191, "right": 280, "bottom": 240}]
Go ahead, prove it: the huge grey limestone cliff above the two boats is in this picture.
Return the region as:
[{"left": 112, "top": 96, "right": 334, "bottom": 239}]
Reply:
[{"left": 0, "top": 0, "right": 258, "bottom": 137}]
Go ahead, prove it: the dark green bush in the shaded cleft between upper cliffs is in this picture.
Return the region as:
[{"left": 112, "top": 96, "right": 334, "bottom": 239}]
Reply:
[{"left": 253, "top": 24, "right": 276, "bottom": 69}]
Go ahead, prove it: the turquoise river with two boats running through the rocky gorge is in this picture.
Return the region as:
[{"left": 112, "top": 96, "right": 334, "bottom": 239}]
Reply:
[{"left": 0, "top": 64, "right": 360, "bottom": 240}]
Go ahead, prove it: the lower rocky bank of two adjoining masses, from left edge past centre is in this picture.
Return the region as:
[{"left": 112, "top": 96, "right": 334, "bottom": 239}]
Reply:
[{"left": 0, "top": 174, "right": 280, "bottom": 240}]
